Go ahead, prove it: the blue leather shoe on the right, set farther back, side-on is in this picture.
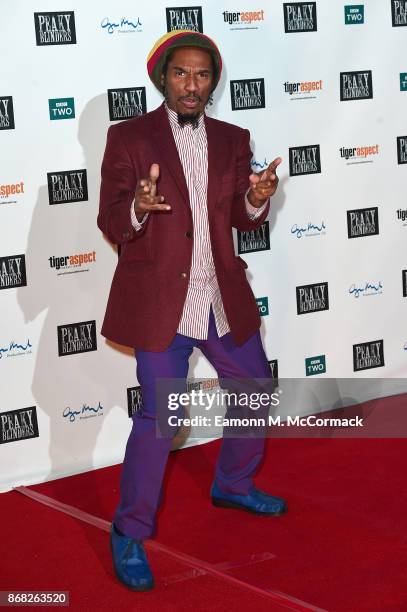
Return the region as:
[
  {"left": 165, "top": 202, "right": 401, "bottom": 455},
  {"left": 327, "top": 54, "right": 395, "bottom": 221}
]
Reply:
[{"left": 211, "top": 481, "right": 287, "bottom": 516}]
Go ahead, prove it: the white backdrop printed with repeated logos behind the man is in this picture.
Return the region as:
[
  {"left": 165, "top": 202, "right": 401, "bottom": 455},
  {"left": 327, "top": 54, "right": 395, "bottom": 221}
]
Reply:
[{"left": 0, "top": 0, "right": 407, "bottom": 490}]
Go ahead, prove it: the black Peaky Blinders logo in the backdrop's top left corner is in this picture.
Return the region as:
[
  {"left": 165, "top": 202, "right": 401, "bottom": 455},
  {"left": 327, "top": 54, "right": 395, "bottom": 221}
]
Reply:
[{"left": 34, "top": 11, "right": 76, "bottom": 46}]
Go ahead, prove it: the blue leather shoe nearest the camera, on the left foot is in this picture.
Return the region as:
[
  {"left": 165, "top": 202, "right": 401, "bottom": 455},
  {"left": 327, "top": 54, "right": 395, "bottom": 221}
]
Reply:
[{"left": 110, "top": 523, "right": 154, "bottom": 591}]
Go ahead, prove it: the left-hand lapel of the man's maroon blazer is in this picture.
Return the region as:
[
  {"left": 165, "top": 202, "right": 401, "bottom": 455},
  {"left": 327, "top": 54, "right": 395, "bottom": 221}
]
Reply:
[{"left": 151, "top": 103, "right": 189, "bottom": 207}]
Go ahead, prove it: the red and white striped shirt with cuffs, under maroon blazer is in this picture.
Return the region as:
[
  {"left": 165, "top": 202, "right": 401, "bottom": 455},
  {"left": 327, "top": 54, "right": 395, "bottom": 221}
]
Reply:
[{"left": 131, "top": 105, "right": 266, "bottom": 340}]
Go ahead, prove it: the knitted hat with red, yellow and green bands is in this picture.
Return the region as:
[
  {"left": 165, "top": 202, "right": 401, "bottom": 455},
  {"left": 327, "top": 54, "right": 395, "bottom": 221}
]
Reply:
[{"left": 147, "top": 30, "right": 222, "bottom": 92}]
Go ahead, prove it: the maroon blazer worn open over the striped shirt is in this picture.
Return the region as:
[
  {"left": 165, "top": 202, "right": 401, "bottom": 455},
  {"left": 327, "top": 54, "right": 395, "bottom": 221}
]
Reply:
[{"left": 97, "top": 105, "right": 269, "bottom": 351}]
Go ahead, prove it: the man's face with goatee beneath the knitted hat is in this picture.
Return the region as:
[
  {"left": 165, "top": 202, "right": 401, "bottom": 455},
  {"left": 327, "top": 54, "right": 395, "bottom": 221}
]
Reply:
[{"left": 161, "top": 47, "right": 214, "bottom": 120}]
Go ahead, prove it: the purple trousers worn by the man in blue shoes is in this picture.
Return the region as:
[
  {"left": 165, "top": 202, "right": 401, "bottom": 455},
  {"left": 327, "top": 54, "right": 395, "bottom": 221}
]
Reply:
[{"left": 113, "top": 310, "right": 271, "bottom": 540}]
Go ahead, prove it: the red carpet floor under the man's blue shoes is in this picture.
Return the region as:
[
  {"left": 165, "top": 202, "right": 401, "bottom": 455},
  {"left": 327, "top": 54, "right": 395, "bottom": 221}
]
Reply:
[{"left": 0, "top": 432, "right": 407, "bottom": 611}]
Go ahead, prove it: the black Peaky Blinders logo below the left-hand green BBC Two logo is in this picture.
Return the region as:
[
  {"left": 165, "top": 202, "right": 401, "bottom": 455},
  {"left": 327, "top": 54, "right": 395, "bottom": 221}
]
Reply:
[{"left": 47, "top": 169, "right": 88, "bottom": 204}]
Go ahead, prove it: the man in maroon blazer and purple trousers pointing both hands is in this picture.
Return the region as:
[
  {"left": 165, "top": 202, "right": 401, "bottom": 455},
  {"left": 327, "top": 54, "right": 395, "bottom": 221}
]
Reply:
[{"left": 98, "top": 31, "right": 286, "bottom": 591}]
